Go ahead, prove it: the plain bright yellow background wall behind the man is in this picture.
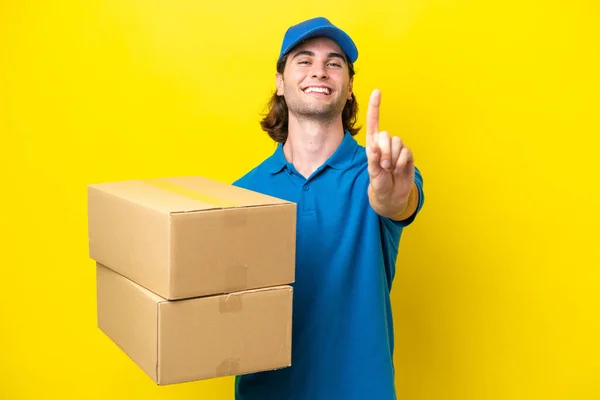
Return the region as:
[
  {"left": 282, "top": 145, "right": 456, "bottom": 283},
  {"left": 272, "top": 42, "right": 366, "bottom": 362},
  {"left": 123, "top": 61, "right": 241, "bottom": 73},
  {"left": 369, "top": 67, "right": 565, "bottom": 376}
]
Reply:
[{"left": 0, "top": 0, "right": 600, "bottom": 400}]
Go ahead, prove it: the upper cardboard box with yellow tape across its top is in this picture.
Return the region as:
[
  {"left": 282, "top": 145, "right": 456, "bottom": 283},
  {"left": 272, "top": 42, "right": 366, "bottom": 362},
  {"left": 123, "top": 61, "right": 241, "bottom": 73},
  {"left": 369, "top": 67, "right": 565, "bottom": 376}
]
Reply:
[{"left": 88, "top": 176, "right": 296, "bottom": 300}]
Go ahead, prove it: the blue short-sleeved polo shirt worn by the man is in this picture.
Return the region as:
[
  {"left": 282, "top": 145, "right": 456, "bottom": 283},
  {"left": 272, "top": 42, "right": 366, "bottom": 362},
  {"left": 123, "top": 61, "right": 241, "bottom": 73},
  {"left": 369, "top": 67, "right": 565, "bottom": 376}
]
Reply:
[{"left": 234, "top": 132, "right": 424, "bottom": 400}]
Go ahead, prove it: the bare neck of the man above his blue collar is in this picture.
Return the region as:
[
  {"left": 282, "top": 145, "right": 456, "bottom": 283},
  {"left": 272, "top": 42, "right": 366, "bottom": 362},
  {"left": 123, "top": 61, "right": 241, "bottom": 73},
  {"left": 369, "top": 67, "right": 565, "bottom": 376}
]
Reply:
[{"left": 283, "top": 114, "right": 344, "bottom": 178}]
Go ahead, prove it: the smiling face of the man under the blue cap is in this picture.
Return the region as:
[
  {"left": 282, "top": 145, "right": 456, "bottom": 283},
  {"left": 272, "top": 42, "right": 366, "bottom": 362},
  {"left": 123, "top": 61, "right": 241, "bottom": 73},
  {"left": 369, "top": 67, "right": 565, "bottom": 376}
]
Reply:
[{"left": 277, "top": 38, "right": 352, "bottom": 120}]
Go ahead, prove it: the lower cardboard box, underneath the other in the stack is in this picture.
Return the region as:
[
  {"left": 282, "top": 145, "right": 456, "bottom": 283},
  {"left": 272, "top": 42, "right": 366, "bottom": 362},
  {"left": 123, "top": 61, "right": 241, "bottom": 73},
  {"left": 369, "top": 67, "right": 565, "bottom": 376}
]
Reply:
[{"left": 96, "top": 263, "right": 293, "bottom": 385}]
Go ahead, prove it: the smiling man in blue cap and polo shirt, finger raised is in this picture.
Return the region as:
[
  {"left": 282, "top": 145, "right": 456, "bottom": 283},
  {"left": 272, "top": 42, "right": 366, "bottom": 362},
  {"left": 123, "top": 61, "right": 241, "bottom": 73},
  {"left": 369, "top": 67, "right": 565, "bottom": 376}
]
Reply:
[{"left": 234, "top": 18, "right": 423, "bottom": 400}]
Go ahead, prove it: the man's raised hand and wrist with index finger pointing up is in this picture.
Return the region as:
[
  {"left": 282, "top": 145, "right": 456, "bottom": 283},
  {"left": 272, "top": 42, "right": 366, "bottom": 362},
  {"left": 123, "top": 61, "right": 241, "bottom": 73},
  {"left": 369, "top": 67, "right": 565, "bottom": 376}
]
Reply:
[{"left": 366, "top": 89, "right": 415, "bottom": 217}]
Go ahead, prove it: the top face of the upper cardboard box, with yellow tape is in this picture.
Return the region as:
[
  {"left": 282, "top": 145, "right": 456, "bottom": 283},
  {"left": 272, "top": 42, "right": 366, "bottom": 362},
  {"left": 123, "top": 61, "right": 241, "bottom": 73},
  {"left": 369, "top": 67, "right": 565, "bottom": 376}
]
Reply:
[{"left": 89, "top": 176, "right": 289, "bottom": 213}]
